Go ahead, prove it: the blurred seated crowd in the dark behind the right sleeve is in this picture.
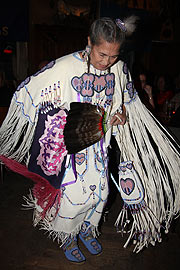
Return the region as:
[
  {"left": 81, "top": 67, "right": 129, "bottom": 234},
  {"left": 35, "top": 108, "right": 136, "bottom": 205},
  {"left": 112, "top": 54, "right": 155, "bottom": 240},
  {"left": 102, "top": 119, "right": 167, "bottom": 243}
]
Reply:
[{"left": 133, "top": 68, "right": 180, "bottom": 127}]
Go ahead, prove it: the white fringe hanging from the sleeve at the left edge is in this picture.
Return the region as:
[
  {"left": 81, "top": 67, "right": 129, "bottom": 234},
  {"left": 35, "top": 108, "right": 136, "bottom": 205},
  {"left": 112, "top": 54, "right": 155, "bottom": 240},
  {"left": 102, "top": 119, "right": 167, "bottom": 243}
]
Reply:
[{"left": 0, "top": 99, "right": 36, "bottom": 163}]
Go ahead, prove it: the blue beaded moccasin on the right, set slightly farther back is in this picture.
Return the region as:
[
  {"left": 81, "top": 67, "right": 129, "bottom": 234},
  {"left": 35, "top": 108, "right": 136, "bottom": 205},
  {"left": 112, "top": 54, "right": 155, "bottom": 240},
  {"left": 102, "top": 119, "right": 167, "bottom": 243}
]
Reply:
[{"left": 79, "top": 221, "right": 102, "bottom": 255}]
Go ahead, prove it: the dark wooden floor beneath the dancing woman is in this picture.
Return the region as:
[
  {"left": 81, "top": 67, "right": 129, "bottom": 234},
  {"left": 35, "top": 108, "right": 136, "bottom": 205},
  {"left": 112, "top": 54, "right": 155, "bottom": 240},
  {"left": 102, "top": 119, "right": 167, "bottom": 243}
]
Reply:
[{"left": 0, "top": 172, "right": 180, "bottom": 270}]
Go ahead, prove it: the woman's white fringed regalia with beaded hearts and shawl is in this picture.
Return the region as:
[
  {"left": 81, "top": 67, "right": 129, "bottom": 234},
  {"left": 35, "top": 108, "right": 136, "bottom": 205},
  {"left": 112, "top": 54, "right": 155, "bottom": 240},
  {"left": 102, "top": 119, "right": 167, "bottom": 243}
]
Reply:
[{"left": 0, "top": 53, "right": 180, "bottom": 252}]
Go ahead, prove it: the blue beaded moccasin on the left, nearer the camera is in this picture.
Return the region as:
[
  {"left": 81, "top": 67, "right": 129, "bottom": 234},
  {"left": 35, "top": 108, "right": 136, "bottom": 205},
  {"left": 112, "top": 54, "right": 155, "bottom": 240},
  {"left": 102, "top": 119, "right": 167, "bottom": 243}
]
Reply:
[{"left": 62, "top": 237, "right": 86, "bottom": 264}]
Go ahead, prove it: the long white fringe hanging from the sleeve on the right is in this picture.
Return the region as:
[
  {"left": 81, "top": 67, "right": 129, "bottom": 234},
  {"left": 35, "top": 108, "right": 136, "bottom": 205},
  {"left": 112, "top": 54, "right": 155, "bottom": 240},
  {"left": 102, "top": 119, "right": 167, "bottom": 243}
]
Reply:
[{"left": 116, "top": 97, "right": 180, "bottom": 252}]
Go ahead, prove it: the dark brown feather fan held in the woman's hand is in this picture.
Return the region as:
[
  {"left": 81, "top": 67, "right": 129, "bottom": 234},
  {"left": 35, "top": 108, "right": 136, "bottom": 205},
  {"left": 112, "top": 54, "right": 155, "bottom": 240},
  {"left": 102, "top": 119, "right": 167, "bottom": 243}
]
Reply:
[{"left": 64, "top": 102, "right": 108, "bottom": 154}]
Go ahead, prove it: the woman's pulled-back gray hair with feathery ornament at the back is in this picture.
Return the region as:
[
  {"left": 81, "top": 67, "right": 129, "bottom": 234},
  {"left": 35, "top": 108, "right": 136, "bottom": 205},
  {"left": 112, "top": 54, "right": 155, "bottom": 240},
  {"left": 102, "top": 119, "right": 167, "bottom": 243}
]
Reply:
[{"left": 89, "top": 15, "right": 138, "bottom": 45}]
